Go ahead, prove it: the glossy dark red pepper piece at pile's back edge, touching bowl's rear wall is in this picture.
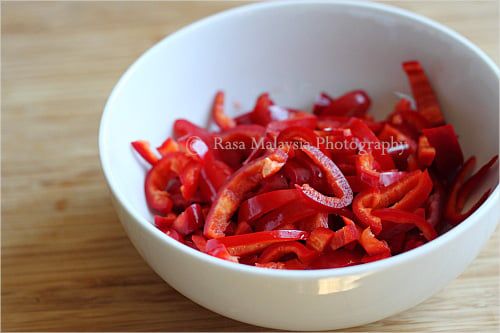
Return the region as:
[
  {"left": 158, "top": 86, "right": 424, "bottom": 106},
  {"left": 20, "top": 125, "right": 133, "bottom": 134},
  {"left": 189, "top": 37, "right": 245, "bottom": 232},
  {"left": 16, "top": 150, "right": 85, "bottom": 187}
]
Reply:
[{"left": 316, "top": 90, "right": 371, "bottom": 117}]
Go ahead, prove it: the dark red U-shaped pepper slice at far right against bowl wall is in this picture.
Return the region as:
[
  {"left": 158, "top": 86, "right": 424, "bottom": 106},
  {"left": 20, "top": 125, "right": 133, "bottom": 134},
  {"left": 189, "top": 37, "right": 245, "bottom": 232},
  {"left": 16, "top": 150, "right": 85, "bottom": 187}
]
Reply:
[{"left": 444, "top": 156, "right": 498, "bottom": 225}]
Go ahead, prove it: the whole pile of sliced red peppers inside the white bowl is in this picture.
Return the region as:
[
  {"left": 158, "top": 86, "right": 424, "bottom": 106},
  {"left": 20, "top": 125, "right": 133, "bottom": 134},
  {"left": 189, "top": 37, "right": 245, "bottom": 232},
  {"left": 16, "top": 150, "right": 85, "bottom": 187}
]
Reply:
[{"left": 132, "top": 61, "right": 498, "bottom": 269}]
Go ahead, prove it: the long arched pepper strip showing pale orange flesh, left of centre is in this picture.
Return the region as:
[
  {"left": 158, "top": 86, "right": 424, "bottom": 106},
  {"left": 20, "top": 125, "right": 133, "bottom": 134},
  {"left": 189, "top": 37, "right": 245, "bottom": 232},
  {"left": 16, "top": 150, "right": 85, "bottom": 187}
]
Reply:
[{"left": 204, "top": 149, "right": 288, "bottom": 238}]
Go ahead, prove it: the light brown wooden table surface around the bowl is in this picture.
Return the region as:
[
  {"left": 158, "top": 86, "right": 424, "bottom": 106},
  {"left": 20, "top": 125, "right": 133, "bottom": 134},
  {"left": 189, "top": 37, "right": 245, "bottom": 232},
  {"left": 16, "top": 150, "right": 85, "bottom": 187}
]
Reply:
[{"left": 1, "top": 1, "right": 499, "bottom": 332}]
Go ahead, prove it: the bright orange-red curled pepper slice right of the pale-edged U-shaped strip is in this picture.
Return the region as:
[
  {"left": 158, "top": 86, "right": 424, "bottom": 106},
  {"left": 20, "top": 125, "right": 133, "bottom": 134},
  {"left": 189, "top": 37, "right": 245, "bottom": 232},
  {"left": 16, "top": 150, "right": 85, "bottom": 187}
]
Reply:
[{"left": 352, "top": 170, "right": 432, "bottom": 235}]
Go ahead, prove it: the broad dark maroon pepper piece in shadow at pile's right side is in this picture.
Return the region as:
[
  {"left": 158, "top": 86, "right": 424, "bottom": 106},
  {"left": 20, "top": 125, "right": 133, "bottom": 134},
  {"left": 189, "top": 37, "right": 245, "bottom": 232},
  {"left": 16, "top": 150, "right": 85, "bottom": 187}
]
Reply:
[{"left": 422, "top": 124, "right": 464, "bottom": 178}]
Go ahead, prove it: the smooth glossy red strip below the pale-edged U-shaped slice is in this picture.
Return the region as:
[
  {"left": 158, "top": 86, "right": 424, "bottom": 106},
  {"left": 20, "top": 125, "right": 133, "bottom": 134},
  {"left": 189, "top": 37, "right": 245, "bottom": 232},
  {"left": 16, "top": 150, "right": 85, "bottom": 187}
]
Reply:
[{"left": 250, "top": 200, "right": 318, "bottom": 231}]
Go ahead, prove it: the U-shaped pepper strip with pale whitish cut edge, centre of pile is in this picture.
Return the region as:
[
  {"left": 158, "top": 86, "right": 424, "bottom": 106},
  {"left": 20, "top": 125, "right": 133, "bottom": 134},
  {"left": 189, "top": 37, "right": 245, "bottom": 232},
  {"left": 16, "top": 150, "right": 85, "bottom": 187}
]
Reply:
[{"left": 295, "top": 145, "right": 353, "bottom": 209}]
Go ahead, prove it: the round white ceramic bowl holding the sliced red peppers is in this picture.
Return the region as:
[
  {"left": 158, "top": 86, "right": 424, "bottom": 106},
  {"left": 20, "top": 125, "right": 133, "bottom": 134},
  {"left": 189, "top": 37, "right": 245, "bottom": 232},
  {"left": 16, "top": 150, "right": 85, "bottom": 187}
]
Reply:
[{"left": 99, "top": 2, "right": 499, "bottom": 330}]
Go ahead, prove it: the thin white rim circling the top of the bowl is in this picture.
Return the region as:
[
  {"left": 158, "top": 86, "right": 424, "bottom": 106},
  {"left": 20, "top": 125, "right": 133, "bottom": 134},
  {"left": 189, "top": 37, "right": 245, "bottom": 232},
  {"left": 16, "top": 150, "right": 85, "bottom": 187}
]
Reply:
[{"left": 98, "top": 0, "right": 500, "bottom": 280}]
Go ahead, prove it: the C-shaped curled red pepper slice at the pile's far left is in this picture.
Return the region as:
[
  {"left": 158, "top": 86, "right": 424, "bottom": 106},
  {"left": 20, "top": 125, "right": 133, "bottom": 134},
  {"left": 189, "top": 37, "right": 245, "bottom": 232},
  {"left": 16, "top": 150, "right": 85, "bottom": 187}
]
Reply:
[{"left": 144, "top": 152, "right": 200, "bottom": 215}]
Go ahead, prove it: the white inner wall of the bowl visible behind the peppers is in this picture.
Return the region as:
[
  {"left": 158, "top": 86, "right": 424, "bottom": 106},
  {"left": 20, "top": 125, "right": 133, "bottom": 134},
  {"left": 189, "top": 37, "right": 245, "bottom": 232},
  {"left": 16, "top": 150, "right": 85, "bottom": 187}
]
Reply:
[{"left": 100, "top": 2, "right": 499, "bottom": 233}]
